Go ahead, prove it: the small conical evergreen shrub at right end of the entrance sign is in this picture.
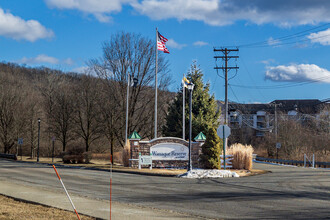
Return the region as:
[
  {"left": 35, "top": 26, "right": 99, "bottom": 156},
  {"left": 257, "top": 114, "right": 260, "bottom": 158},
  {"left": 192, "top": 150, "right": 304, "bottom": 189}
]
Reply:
[{"left": 200, "top": 128, "right": 223, "bottom": 169}]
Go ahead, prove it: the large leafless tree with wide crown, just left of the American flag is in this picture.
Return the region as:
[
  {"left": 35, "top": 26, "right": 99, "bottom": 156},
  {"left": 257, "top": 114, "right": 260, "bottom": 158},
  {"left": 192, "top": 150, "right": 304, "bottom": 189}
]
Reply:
[{"left": 89, "top": 32, "right": 170, "bottom": 146}]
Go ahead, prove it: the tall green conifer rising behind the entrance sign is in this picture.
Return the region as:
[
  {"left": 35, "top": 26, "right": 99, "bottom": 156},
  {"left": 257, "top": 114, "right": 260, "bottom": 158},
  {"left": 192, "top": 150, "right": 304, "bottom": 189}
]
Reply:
[{"left": 163, "top": 62, "right": 220, "bottom": 139}]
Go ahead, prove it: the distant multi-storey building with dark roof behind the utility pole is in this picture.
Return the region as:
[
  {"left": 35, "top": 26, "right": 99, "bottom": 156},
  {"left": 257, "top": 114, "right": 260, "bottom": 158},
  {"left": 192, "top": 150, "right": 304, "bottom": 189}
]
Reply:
[{"left": 219, "top": 99, "right": 330, "bottom": 136}]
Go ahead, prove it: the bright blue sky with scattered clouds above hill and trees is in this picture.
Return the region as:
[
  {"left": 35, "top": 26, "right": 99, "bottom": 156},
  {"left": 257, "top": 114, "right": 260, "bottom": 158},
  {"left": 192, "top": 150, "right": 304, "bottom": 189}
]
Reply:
[{"left": 0, "top": 0, "right": 330, "bottom": 103}]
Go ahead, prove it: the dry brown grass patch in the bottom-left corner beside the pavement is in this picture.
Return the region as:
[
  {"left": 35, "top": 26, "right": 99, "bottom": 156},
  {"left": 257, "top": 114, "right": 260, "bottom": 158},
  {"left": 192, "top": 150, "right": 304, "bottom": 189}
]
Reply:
[{"left": 0, "top": 195, "right": 95, "bottom": 220}]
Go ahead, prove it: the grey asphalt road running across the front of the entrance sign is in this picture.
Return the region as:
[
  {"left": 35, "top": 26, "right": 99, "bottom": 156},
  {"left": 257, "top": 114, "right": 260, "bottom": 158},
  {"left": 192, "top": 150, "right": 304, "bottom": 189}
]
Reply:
[{"left": 0, "top": 160, "right": 330, "bottom": 219}]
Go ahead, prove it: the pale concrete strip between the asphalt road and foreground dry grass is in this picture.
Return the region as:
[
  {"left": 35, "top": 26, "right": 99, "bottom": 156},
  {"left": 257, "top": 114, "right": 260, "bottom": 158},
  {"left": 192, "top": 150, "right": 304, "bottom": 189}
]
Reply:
[{"left": 0, "top": 180, "right": 199, "bottom": 220}]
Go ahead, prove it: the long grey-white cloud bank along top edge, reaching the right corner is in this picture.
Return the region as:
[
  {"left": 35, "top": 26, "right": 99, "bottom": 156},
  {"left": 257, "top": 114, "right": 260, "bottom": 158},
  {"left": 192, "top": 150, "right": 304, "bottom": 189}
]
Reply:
[{"left": 131, "top": 0, "right": 330, "bottom": 26}]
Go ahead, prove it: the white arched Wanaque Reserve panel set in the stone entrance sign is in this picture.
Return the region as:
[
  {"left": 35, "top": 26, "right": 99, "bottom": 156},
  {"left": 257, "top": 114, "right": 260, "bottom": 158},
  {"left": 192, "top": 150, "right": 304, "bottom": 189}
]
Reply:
[{"left": 150, "top": 143, "right": 189, "bottom": 160}]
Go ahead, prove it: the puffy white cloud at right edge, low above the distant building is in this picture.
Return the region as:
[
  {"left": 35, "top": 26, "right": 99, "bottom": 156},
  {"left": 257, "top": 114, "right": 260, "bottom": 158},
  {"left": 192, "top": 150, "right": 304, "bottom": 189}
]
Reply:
[{"left": 265, "top": 64, "right": 330, "bottom": 83}]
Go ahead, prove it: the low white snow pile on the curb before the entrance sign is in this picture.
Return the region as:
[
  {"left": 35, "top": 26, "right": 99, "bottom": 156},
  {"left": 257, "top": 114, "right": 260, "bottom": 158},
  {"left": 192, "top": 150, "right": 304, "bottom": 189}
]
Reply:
[{"left": 178, "top": 169, "right": 239, "bottom": 179}]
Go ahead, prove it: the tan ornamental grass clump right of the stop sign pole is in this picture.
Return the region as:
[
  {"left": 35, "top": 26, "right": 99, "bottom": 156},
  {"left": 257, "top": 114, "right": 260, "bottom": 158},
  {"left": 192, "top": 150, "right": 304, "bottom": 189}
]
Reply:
[{"left": 227, "top": 143, "right": 253, "bottom": 170}]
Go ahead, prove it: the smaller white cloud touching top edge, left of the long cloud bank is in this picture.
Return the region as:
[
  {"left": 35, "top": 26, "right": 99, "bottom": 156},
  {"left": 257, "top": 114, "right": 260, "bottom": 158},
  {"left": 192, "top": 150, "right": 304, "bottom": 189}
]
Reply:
[{"left": 45, "top": 0, "right": 135, "bottom": 22}]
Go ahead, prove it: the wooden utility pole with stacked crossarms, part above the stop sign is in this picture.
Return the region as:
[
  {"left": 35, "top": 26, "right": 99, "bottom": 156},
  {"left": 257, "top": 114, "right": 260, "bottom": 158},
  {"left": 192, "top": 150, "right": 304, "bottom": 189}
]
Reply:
[{"left": 213, "top": 48, "right": 239, "bottom": 124}]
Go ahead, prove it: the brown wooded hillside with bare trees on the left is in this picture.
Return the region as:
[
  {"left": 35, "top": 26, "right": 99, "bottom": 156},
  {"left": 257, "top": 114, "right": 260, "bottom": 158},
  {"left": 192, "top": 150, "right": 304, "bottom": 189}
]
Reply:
[{"left": 0, "top": 62, "right": 174, "bottom": 156}]
